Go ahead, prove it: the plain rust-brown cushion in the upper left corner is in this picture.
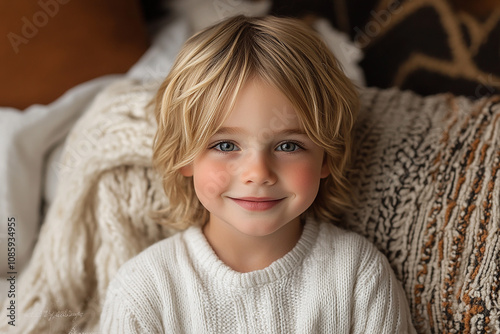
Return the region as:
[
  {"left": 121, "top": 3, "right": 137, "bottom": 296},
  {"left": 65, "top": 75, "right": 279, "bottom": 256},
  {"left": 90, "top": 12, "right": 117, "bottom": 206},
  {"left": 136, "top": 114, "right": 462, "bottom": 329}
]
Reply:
[{"left": 0, "top": 0, "right": 148, "bottom": 109}]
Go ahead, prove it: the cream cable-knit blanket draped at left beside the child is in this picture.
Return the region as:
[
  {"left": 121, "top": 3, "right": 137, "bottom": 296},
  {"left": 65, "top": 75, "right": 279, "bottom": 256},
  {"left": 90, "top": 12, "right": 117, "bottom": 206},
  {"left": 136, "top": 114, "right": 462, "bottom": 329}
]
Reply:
[{"left": 0, "top": 80, "right": 175, "bottom": 334}]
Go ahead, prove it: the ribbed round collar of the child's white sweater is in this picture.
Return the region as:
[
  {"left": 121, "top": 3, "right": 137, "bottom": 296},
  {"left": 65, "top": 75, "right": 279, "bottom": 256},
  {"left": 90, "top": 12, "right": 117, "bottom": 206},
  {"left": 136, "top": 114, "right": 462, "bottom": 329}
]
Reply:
[{"left": 184, "top": 219, "right": 319, "bottom": 288}]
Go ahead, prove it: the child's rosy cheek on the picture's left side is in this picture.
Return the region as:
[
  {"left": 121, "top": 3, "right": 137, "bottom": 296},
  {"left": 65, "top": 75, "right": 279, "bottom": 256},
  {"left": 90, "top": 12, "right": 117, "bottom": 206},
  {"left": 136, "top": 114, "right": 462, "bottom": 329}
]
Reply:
[{"left": 193, "top": 159, "right": 231, "bottom": 205}]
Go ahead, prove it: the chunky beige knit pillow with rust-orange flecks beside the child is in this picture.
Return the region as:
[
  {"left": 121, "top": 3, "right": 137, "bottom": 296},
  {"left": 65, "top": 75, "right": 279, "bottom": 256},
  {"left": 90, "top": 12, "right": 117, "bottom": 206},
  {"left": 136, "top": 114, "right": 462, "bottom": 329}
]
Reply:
[{"left": 346, "top": 89, "right": 500, "bottom": 333}]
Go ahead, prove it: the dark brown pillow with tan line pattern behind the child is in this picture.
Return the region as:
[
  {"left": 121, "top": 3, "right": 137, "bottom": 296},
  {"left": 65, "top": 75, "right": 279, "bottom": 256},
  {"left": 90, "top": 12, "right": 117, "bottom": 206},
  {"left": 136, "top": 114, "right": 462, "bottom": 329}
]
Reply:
[{"left": 272, "top": 0, "right": 500, "bottom": 99}]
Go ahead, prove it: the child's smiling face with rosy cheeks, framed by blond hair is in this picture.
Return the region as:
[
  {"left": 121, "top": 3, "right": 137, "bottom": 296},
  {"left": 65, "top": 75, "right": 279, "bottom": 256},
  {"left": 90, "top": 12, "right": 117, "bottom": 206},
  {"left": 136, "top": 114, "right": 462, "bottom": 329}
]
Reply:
[{"left": 181, "top": 79, "right": 329, "bottom": 237}]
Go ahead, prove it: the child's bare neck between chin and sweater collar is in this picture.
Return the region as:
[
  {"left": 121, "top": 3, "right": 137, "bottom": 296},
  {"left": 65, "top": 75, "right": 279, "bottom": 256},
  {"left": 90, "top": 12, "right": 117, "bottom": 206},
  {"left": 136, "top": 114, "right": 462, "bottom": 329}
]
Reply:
[{"left": 203, "top": 218, "right": 303, "bottom": 273}]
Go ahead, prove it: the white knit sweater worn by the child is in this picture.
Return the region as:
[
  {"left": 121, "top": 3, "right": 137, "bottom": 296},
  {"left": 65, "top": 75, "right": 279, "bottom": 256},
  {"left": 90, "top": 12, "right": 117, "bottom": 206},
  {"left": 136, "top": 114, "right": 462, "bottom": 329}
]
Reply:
[{"left": 101, "top": 222, "right": 414, "bottom": 334}]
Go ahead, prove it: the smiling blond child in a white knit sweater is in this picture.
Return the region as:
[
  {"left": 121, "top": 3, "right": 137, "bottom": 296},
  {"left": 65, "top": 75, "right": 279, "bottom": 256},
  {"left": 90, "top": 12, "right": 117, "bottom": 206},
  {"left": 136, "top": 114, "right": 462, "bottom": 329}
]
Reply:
[{"left": 101, "top": 16, "right": 414, "bottom": 334}]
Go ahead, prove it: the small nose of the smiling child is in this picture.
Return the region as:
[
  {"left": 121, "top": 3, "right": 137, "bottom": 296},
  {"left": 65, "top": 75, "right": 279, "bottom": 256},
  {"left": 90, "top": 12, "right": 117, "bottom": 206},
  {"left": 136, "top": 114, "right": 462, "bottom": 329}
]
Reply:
[{"left": 241, "top": 151, "right": 277, "bottom": 185}]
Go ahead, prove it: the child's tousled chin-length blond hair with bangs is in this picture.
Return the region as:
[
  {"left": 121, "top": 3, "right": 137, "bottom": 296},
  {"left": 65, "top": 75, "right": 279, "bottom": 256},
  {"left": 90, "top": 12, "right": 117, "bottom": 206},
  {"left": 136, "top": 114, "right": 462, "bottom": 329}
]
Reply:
[{"left": 153, "top": 16, "right": 359, "bottom": 228}]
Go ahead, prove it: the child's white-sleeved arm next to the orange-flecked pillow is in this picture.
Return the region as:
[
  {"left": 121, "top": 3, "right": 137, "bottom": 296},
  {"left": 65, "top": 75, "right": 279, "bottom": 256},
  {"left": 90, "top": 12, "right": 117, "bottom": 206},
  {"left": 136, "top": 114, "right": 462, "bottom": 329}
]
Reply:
[{"left": 351, "top": 245, "right": 416, "bottom": 334}]
